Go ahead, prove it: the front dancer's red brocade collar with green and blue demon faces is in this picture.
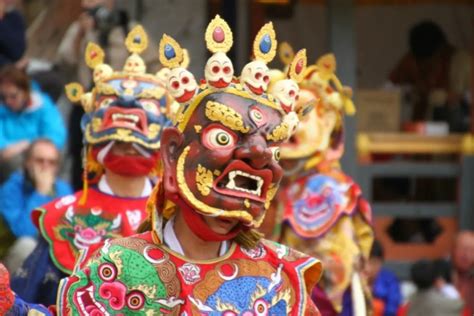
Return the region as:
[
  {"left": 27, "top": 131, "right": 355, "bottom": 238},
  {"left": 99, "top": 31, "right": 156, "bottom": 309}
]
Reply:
[{"left": 57, "top": 233, "right": 321, "bottom": 316}]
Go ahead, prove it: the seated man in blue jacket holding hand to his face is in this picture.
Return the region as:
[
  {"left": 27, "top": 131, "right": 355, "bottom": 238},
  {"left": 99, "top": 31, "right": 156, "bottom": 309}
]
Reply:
[{"left": 0, "top": 138, "right": 73, "bottom": 271}]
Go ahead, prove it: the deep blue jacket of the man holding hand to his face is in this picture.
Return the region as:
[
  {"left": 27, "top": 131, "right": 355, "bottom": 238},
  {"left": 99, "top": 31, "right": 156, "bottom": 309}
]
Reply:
[{"left": 0, "top": 172, "right": 73, "bottom": 237}]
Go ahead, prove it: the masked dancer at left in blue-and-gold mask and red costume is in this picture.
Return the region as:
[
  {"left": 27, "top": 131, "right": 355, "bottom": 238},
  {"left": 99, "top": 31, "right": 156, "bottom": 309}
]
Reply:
[{"left": 8, "top": 26, "right": 172, "bottom": 306}]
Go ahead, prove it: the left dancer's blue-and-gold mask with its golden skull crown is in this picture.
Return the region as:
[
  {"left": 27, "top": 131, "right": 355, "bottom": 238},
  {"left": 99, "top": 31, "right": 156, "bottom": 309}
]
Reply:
[{"left": 66, "top": 25, "right": 173, "bottom": 202}]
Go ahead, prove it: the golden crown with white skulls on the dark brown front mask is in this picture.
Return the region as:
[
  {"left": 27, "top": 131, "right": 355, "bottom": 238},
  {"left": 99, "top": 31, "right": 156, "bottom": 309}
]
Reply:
[{"left": 159, "top": 15, "right": 306, "bottom": 136}]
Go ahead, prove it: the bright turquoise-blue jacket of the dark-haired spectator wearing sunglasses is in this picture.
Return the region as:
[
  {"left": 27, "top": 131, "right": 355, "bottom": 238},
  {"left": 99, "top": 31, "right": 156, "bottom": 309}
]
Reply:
[{"left": 0, "top": 90, "right": 66, "bottom": 150}]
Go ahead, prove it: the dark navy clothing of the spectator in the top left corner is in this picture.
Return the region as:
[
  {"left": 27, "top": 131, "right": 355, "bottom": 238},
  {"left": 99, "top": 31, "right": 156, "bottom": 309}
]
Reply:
[{"left": 0, "top": 11, "right": 26, "bottom": 64}]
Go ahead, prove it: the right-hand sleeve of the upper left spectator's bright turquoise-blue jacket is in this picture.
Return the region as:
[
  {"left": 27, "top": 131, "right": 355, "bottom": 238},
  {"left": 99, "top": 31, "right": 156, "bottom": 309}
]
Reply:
[{"left": 40, "top": 93, "right": 66, "bottom": 150}]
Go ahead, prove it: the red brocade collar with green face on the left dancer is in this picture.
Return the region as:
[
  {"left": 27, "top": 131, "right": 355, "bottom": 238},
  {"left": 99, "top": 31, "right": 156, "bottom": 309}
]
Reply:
[{"left": 33, "top": 188, "right": 147, "bottom": 274}]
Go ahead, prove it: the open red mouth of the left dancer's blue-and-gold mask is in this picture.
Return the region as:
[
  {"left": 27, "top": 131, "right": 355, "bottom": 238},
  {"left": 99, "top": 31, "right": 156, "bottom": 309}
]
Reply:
[{"left": 102, "top": 107, "right": 147, "bottom": 135}]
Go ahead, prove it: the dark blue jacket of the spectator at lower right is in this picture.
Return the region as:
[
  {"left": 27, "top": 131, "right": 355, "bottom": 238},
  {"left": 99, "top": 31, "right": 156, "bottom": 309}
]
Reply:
[{"left": 372, "top": 268, "right": 402, "bottom": 316}]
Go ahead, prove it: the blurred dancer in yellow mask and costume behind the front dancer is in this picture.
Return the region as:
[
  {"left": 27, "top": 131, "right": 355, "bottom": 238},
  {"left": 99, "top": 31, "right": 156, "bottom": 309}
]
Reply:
[{"left": 266, "top": 43, "right": 373, "bottom": 316}]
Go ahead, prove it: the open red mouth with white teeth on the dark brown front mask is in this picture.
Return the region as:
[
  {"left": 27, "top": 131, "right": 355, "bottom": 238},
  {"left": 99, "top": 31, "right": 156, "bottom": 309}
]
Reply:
[{"left": 214, "top": 160, "right": 273, "bottom": 202}]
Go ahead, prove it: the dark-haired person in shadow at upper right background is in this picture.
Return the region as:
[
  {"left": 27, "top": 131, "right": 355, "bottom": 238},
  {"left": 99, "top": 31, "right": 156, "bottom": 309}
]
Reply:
[{"left": 389, "top": 20, "right": 471, "bottom": 131}]
